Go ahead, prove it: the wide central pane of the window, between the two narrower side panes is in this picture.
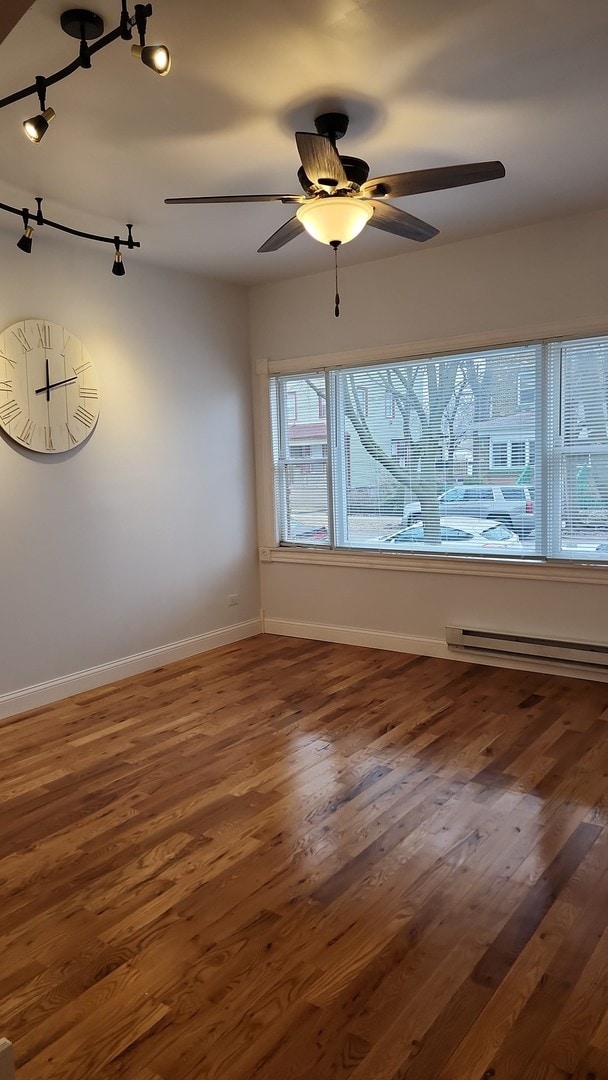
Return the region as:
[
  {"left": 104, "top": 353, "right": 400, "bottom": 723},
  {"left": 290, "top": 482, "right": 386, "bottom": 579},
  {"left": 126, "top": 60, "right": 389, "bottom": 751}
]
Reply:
[{"left": 336, "top": 346, "right": 539, "bottom": 553}]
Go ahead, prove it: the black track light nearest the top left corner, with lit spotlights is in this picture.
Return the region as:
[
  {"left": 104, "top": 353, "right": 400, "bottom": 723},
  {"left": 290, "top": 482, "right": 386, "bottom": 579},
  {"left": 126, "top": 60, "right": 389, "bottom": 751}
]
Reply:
[{"left": 0, "top": 0, "right": 171, "bottom": 143}]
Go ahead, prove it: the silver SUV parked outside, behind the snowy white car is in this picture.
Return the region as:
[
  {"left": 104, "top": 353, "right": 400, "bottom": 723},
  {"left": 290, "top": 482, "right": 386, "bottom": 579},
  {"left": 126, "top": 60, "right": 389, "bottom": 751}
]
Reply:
[{"left": 402, "top": 484, "right": 535, "bottom": 537}]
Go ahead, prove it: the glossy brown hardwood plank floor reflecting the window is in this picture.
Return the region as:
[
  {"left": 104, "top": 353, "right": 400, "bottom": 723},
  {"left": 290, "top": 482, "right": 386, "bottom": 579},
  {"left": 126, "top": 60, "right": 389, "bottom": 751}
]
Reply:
[{"left": 0, "top": 636, "right": 608, "bottom": 1080}]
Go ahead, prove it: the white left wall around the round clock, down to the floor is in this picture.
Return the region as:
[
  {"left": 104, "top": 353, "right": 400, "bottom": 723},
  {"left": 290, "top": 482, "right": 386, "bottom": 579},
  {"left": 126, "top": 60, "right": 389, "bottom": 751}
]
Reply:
[{"left": 0, "top": 234, "right": 259, "bottom": 715}]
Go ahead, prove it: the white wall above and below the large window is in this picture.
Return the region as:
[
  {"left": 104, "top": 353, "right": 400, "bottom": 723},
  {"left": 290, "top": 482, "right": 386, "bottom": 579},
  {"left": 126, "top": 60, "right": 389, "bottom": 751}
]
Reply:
[{"left": 251, "top": 212, "right": 608, "bottom": 673}]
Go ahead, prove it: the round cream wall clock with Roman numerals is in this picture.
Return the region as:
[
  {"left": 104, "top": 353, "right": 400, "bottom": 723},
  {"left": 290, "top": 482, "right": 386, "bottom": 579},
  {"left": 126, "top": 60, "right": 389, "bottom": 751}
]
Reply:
[{"left": 0, "top": 319, "right": 99, "bottom": 454}]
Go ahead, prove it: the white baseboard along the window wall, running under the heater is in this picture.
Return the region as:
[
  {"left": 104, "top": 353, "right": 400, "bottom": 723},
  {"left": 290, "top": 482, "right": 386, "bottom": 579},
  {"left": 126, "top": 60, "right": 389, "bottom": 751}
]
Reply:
[{"left": 264, "top": 615, "right": 608, "bottom": 683}]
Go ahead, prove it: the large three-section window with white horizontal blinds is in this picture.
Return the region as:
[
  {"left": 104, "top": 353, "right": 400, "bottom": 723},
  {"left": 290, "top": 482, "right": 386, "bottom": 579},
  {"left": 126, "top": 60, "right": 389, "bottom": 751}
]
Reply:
[{"left": 271, "top": 338, "right": 608, "bottom": 562}]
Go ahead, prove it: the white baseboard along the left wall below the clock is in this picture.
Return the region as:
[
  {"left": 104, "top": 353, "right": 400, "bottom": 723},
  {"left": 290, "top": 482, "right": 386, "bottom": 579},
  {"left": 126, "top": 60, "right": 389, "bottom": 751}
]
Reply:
[{"left": 0, "top": 618, "right": 262, "bottom": 720}]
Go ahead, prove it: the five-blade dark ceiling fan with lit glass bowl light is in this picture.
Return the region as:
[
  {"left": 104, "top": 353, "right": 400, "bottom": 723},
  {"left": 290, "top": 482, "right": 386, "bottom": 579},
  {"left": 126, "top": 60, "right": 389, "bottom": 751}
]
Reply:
[{"left": 165, "top": 112, "right": 504, "bottom": 252}]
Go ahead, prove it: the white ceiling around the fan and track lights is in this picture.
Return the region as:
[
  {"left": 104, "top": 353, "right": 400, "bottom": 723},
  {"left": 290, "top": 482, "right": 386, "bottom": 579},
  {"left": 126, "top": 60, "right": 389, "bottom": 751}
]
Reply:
[{"left": 0, "top": 0, "right": 608, "bottom": 283}]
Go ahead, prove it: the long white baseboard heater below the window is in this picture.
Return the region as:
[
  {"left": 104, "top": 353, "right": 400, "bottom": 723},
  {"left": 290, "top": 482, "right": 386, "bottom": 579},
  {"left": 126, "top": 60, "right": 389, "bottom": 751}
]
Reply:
[{"left": 445, "top": 626, "right": 608, "bottom": 669}]
